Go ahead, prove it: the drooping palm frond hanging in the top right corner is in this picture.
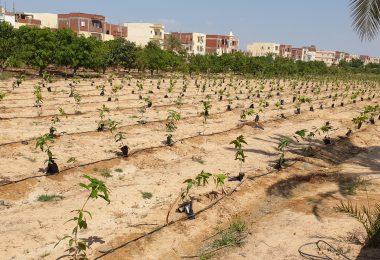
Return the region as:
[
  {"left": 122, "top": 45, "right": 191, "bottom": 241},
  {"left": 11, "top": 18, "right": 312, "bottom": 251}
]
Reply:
[{"left": 350, "top": 0, "right": 380, "bottom": 41}]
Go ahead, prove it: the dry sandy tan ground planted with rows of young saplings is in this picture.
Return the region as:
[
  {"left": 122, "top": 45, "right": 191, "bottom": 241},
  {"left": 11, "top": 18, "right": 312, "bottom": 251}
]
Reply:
[{"left": 0, "top": 74, "right": 380, "bottom": 259}]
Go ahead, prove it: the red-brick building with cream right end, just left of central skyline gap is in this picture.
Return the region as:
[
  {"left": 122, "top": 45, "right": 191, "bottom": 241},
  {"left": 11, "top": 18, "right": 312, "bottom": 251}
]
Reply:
[{"left": 206, "top": 32, "right": 239, "bottom": 55}]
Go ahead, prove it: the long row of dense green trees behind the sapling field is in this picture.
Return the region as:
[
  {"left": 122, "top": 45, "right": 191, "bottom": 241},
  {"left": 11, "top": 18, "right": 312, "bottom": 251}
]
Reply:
[{"left": 0, "top": 22, "right": 380, "bottom": 76}]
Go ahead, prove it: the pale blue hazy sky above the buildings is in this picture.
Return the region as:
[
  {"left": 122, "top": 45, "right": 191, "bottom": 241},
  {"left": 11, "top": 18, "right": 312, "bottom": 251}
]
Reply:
[{"left": 5, "top": 0, "right": 380, "bottom": 57}]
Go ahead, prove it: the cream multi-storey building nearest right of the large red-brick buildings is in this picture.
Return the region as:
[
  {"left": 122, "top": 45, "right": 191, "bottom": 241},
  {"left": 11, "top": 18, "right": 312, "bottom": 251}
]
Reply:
[{"left": 124, "top": 23, "right": 165, "bottom": 47}]
